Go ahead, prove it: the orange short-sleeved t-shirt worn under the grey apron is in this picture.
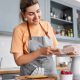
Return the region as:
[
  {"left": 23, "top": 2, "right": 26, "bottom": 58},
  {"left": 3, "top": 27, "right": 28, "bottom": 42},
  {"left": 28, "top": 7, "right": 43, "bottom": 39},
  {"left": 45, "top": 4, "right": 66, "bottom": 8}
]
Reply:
[{"left": 10, "top": 21, "right": 58, "bottom": 54}]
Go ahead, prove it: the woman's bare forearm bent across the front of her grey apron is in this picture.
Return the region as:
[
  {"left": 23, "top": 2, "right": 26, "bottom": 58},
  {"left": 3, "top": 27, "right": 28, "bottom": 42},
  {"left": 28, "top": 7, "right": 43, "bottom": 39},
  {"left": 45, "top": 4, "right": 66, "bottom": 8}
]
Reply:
[{"left": 14, "top": 50, "right": 41, "bottom": 66}]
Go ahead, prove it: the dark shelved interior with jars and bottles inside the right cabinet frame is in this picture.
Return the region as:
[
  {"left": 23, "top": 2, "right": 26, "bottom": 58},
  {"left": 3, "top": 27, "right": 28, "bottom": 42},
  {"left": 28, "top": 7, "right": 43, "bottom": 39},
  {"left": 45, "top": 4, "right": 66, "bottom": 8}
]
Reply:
[{"left": 50, "top": 1, "right": 74, "bottom": 37}]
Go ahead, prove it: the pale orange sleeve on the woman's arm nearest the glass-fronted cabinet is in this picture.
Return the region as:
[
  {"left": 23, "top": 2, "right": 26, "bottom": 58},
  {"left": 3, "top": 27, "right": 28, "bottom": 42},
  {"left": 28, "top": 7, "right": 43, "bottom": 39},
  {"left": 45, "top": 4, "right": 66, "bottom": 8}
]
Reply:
[{"left": 48, "top": 22, "right": 58, "bottom": 47}]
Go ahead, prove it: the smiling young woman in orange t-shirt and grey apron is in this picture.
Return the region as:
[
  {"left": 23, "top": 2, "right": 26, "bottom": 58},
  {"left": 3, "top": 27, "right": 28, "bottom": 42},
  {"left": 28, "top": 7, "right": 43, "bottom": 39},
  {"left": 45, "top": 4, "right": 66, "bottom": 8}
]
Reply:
[{"left": 11, "top": 0, "right": 60, "bottom": 75}]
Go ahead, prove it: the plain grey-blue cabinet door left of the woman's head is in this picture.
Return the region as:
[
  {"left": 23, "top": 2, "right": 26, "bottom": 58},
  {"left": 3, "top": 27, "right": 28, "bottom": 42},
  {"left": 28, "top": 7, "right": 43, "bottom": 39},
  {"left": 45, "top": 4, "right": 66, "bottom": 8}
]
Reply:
[{"left": 0, "top": 0, "right": 20, "bottom": 32}]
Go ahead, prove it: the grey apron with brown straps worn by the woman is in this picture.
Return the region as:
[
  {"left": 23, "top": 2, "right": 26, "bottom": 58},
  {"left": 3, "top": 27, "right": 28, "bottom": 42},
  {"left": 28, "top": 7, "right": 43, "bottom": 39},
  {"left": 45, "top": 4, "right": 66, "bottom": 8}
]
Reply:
[{"left": 20, "top": 21, "right": 57, "bottom": 75}]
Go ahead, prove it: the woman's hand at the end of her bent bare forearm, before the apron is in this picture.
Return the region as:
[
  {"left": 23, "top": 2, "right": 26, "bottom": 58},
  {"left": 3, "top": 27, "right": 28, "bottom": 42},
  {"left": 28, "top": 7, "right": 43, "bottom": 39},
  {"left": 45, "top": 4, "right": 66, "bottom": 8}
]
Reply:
[{"left": 38, "top": 47, "right": 61, "bottom": 56}]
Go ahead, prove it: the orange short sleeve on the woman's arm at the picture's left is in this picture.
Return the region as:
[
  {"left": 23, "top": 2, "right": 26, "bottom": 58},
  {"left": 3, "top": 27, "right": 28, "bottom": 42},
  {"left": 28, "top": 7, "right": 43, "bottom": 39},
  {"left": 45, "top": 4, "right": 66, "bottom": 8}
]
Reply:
[{"left": 10, "top": 28, "right": 23, "bottom": 53}]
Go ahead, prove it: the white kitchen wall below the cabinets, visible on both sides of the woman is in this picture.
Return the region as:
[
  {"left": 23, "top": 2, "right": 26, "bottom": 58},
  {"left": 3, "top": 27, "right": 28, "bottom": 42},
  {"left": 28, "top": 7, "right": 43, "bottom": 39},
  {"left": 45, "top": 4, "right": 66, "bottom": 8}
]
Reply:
[{"left": 0, "top": 35, "right": 80, "bottom": 68}]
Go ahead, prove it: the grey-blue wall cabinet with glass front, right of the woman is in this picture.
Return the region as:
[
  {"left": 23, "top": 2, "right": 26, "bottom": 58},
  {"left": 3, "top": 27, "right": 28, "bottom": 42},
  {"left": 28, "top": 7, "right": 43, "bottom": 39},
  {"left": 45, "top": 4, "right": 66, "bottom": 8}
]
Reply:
[{"left": 45, "top": 0, "right": 80, "bottom": 43}]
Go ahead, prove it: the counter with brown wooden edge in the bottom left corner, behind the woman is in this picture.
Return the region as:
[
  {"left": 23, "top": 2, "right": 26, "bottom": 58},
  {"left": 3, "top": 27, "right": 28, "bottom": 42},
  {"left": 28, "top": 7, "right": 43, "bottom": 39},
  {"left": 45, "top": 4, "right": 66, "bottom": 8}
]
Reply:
[{"left": 0, "top": 67, "right": 20, "bottom": 80}]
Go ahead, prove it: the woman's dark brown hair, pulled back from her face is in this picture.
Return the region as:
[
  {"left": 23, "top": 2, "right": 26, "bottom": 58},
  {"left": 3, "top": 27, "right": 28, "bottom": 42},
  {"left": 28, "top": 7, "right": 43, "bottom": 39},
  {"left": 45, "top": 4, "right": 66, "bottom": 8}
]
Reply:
[{"left": 20, "top": 0, "right": 39, "bottom": 21}]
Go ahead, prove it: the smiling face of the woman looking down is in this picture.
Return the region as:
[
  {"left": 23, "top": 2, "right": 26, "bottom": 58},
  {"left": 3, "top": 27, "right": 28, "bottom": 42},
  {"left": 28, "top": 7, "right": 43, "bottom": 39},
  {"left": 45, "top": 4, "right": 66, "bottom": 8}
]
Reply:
[{"left": 25, "top": 4, "right": 41, "bottom": 25}]
